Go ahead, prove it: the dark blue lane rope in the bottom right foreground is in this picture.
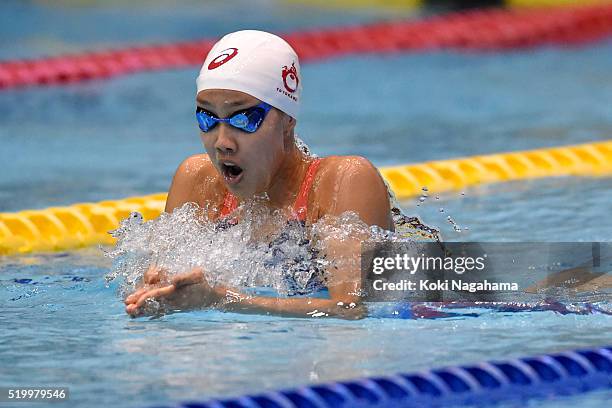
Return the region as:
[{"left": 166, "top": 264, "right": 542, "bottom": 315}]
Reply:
[{"left": 151, "top": 347, "right": 612, "bottom": 408}]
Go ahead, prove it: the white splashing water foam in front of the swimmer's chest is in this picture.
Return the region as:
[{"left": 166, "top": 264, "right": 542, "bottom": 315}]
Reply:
[{"left": 105, "top": 197, "right": 435, "bottom": 302}]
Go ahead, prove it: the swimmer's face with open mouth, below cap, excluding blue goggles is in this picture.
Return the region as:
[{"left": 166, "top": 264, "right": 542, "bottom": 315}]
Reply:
[{"left": 196, "top": 89, "right": 295, "bottom": 198}]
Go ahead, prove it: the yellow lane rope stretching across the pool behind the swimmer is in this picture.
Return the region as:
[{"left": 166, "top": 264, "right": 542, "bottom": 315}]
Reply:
[{"left": 0, "top": 140, "right": 612, "bottom": 255}]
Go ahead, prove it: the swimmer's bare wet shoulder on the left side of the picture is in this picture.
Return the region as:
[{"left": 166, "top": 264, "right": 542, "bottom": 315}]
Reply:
[{"left": 166, "top": 154, "right": 224, "bottom": 212}]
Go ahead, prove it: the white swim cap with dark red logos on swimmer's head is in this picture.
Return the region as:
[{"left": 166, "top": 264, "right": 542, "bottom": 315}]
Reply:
[{"left": 196, "top": 30, "right": 302, "bottom": 119}]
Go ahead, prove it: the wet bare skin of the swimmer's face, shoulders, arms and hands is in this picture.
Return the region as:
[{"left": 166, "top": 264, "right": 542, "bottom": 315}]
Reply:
[{"left": 125, "top": 89, "right": 393, "bottom": 318}]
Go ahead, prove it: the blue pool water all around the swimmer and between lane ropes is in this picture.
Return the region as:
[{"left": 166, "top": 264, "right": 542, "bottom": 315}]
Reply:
[{"left": 0, "top": 1, "right": 612, "bottom": 407}]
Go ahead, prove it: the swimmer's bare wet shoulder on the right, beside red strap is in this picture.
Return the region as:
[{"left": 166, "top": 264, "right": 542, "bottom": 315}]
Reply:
[{"left": 313, "top": 156, "right": 391, "bottom": 229}]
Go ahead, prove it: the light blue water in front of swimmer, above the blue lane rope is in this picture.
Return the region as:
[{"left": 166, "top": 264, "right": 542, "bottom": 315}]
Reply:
[{"left": 0, "top": 249, "right": 612, "bottom": 407}]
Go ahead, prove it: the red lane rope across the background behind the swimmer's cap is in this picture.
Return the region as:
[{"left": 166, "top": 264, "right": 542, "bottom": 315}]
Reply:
[{"left": 0, "top": 5, "right": 612, "bottom": 89}]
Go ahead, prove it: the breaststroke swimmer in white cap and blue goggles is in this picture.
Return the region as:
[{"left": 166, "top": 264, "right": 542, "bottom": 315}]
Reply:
[{"left": 125, "top": 30, "right": 393, "bottom": 318}]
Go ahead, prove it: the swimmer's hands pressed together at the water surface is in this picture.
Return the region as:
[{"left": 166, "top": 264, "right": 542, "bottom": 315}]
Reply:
[{"left": 125, "top": 266, "right": 225, "bottom": 317}]
